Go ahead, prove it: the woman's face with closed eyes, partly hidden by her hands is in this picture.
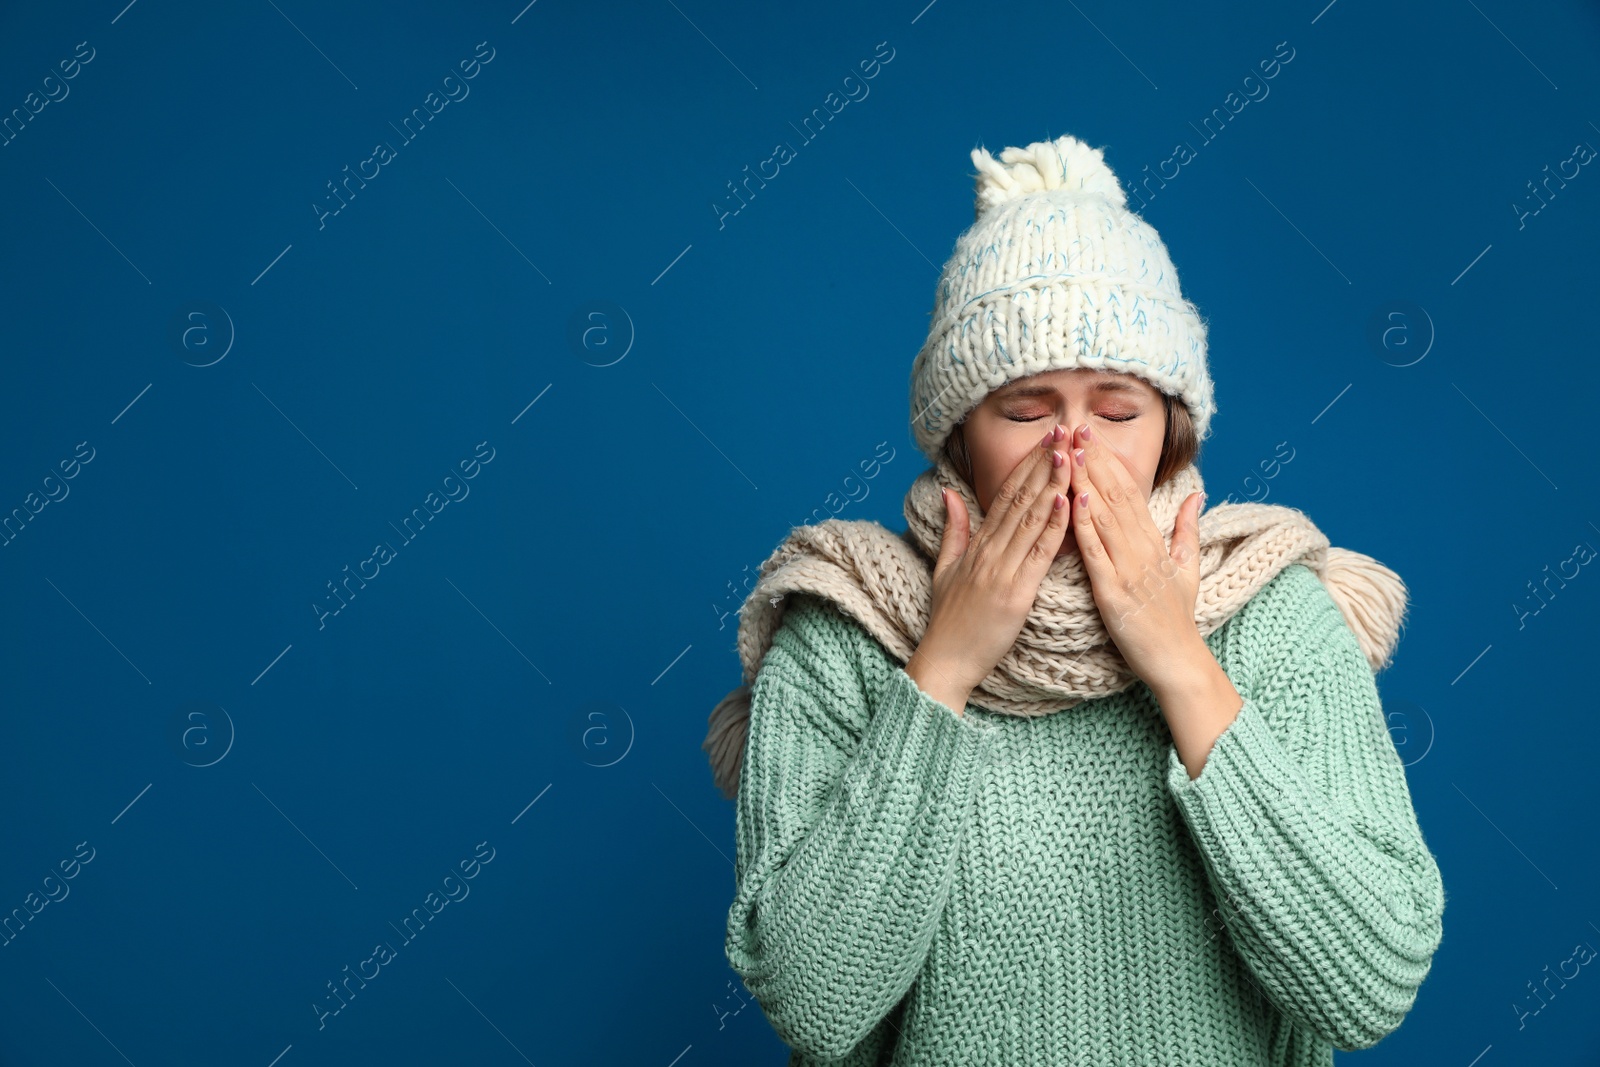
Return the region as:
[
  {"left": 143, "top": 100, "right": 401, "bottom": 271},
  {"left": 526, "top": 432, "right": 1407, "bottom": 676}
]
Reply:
[{"left": 963, "top": 368, "right": 1166, "bottom": 557}]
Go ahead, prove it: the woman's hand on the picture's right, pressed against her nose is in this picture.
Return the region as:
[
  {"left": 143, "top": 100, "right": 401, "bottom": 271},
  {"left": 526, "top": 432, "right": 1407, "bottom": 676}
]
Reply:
[{"left": 1069, "top": 426, "right": 1210, "bottom": 694}]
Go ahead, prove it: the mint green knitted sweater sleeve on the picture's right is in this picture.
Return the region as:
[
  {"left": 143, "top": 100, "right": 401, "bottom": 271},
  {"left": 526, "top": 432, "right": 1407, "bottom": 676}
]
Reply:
[{"left": 1166, "top": 565, "right": 1445, "bottom": 1051}]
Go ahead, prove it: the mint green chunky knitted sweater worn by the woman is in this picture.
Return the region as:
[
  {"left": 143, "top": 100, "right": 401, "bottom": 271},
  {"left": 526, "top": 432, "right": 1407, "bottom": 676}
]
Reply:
[{"left": 726, "top": 563, "right": 1445, "bottom": 1067}]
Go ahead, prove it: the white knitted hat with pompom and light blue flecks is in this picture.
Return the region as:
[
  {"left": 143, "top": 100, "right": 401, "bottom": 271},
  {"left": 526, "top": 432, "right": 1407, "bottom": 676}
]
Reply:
[{"left": 910, "top": 134, "right": 1216, "bottom": 462}]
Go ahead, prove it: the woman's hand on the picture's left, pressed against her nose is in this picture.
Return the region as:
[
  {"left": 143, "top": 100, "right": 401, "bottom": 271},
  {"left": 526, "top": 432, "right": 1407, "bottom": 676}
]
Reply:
[{"left": 906, "top": 426, "right": 1072, "bottom": 713}]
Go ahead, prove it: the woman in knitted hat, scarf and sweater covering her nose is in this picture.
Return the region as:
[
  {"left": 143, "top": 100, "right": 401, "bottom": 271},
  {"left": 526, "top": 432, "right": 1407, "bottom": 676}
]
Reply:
[{"left": 706, "top": 136, "right": 1445, "bottom": 1067}]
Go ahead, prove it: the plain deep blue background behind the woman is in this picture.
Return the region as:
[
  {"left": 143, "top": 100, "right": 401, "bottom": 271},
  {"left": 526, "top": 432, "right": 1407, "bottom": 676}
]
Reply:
[{"left": 0, "top": 0, "right": 1600, "bottom": 1067}]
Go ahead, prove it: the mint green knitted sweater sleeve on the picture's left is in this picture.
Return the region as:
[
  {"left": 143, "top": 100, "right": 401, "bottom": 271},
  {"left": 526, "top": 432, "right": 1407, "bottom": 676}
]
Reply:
[{"left": 726, "top": 598, "right": 994, "bottom": 1059}]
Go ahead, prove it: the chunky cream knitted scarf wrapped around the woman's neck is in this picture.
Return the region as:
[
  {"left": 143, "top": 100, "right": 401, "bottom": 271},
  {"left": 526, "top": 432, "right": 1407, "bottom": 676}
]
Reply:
[{"left": 701, "top": 454, "right": 1406, "bottom": 798}]
